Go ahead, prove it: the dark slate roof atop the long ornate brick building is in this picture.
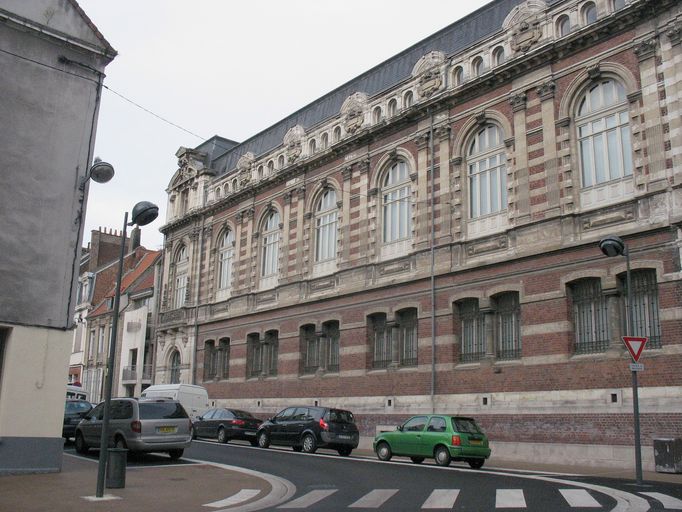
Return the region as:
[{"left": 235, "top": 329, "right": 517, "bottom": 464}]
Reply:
[{"left": 206, "top": 0, "right": 563, "bottom": 175}]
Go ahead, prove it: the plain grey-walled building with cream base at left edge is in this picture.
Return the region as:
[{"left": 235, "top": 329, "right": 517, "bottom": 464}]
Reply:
[{"left": 0, "top": 0, "right": 116, "bottom": 474}]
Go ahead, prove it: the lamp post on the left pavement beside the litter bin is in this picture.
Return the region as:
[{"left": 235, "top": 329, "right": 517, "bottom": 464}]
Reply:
[{"left": 96, "top": 201, "right": 159, "bottom": 498}]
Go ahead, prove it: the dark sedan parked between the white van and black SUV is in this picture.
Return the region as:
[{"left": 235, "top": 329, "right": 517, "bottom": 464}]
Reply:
[{"left": 194, "top": 407, "right": 263, "bottom": 446}]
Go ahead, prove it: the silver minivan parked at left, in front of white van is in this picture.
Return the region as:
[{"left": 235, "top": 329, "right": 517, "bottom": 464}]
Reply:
[{"left": 75, "top": 398, "right": 192, "bottom": 459}]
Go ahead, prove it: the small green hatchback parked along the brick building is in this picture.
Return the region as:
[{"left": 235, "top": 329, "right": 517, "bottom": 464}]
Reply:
[{"left": 374, "top": 414, "right": 490, "bottom": 469}]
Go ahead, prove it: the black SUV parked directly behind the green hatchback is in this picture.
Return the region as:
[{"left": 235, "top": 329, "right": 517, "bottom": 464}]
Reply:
[{"left": 256, "top": 406, "right": 360, "bottom": 456}]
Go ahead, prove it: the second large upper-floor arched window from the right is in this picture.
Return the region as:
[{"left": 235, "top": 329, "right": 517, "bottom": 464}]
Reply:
[{"left": 467, "top": 124, "right": 507, "bottom": 219}]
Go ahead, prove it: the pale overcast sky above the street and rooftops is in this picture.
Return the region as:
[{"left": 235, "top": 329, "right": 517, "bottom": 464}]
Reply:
[{"left": 77, "top": 0, "right": 489, "bottom": 249}]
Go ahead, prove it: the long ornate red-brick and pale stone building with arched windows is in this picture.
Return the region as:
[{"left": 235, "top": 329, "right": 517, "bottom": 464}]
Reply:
[{"left": 156, "top": 0, "right": 682, "bottom": 468}]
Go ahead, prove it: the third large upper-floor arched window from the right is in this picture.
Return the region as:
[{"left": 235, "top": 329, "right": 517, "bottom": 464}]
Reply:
[{"left": 381, "top": 160, "right": 412, "bottom": 244}]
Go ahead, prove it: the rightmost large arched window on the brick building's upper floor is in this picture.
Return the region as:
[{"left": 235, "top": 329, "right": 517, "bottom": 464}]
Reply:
[{"left": 576, "top": 79, "right": 632, "bottom": 187}]
